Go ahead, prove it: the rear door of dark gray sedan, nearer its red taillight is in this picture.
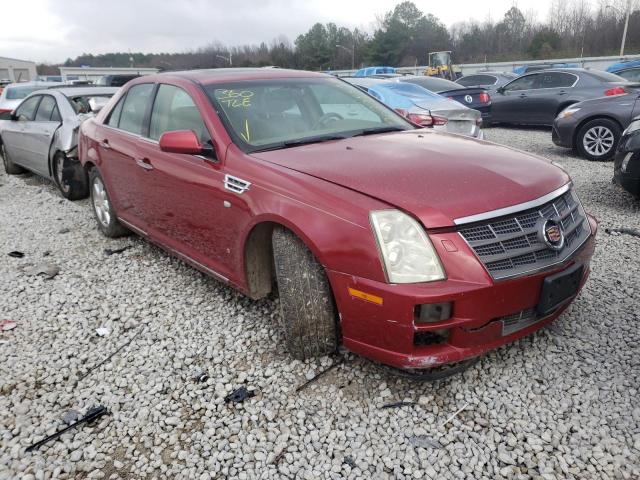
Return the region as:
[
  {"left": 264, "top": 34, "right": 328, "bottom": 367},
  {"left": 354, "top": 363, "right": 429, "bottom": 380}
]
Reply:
[{"left": 526, "top": 72, "right": 578, "bottom": 125}]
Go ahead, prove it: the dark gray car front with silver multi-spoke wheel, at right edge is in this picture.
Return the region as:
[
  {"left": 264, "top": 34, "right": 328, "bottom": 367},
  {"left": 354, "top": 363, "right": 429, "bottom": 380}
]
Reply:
[{"left": 551, "top": 86, "right": 640, "bottom": 160}]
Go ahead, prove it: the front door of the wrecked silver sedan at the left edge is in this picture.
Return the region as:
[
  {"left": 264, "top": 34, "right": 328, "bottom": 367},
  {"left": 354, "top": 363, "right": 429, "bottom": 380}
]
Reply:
[{"left": 2, "top": 95, "right": 42, "bottom": 170}]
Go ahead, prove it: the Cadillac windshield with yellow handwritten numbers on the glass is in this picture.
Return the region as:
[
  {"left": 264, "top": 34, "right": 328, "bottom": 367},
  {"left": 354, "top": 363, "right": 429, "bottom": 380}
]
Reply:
[{"left": 204, "top": 78, "right": 415, "bottom": 152}]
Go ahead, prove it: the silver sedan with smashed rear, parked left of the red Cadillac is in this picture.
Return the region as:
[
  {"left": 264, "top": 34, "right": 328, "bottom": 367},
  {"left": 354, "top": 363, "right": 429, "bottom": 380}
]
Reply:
[{"left": 0, "top": 87, "right": 118, "bottom": 200}]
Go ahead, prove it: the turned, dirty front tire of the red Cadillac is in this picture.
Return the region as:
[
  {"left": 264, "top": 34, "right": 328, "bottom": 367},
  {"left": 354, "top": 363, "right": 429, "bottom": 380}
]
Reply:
[{"left": 272, "top": 227, "right": 338, "bottom": 360}]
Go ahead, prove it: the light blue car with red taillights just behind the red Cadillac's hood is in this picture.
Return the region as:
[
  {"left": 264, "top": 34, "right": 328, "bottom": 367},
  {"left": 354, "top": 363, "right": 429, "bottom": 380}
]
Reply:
[{"left": 344, "top": 77, "right": 483, "bottom": 139}]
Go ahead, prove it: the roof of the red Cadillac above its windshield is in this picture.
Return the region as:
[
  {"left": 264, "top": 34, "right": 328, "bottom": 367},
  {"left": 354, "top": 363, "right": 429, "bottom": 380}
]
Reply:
[{"left": 149, "top": 68, "right": 324, "bottom": 85}]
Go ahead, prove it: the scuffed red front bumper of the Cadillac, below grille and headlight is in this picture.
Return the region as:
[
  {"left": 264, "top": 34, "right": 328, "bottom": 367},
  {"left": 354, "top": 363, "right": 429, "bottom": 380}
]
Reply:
[{"left": 328, "top": 217, "right": 597, "bottom": 369}]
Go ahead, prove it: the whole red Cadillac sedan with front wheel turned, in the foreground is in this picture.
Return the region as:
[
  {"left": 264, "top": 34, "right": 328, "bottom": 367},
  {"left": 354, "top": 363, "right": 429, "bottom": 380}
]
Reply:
[{"left": 79, "top": 69, "right": 597, "bottom": 370}]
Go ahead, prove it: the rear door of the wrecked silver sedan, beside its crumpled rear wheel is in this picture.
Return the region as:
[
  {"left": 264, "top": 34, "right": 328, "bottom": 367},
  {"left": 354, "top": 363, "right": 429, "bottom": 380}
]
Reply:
[{"left": 25, "top": 95, "right": 60, "bottom": 177}]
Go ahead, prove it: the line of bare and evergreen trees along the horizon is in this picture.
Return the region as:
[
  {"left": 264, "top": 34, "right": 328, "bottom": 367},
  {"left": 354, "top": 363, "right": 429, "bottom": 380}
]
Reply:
[{"left": 39, "top": 0, "right": 640, "bottom": 74}]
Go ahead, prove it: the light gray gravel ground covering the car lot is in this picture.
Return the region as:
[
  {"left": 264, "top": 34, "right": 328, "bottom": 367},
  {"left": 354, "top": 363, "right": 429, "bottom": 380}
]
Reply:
[{"left": 0, "top": 129, "right": 640, "bottom": 480}]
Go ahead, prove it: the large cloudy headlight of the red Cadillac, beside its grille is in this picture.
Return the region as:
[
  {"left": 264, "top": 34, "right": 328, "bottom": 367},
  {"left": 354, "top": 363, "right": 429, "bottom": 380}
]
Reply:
[{"left": 370, "top": 210, "right": 445, "bottom": 283}]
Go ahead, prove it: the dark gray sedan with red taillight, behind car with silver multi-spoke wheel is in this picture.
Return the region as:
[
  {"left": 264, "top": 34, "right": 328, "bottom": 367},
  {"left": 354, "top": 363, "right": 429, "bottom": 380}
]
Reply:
[{"left": 491, "top": 68, "right": 632, "bottom": 125}]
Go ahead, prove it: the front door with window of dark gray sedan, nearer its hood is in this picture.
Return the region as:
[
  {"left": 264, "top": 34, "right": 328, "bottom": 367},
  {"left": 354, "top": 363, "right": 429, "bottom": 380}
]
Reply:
[{"left": 491, "top": 73, "right": 539, "bottom": 124}]
